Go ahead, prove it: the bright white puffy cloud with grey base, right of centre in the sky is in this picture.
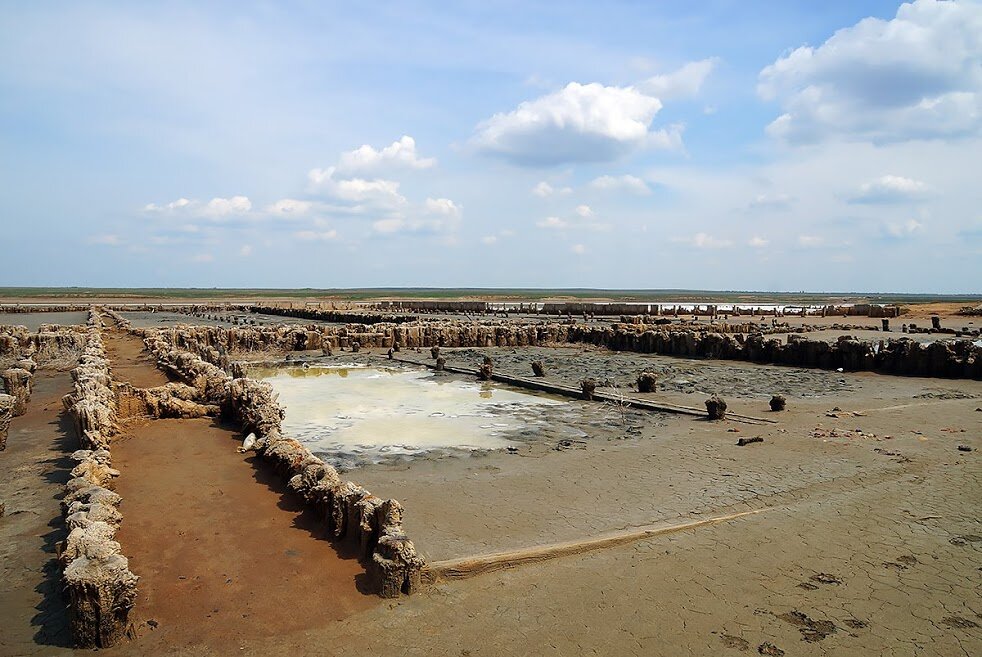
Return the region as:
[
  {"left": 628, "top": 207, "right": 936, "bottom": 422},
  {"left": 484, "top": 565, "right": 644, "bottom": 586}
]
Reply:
[{"left": 471, "top": 82, "right": 677, "bottom": 166}]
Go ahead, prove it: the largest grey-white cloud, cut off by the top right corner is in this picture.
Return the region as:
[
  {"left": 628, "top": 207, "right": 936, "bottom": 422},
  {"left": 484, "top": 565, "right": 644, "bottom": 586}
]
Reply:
[{"left": 757, "top": 0, "right": 982, "bottom": 143}]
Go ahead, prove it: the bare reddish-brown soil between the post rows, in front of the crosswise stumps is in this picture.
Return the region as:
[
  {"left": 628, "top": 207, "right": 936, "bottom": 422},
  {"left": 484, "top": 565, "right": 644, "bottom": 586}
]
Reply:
[{"left": 112, "top": 419, "right": 379, "bottom": 652}]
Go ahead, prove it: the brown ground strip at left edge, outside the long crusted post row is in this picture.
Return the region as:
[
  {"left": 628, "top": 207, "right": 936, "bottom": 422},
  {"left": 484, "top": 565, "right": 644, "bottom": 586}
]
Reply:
[{"left": 0, "top": 371, "right": 78, "bottom": 655}]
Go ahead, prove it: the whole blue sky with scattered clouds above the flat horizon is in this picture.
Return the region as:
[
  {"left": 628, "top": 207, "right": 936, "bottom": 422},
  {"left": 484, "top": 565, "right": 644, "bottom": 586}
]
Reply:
[{"left": 0, "top": 0, "right": 982, "bottom": 293}]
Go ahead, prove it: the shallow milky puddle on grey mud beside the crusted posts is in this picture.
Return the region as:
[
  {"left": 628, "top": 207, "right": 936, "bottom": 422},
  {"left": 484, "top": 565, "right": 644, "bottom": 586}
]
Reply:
[{"left": 250, "top": 365, "right": 565, "bottom": 468}]
